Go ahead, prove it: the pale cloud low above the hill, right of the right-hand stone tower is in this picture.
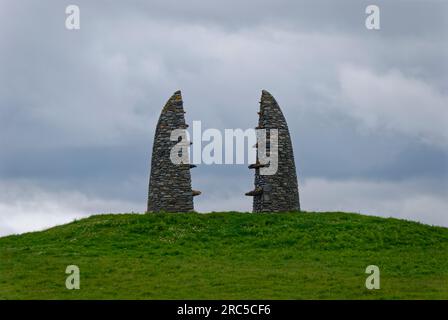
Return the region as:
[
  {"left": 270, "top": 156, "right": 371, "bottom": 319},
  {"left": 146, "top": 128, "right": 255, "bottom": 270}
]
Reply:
[{"left": 302, "top": 179, "right": 448, "bottom": 227}]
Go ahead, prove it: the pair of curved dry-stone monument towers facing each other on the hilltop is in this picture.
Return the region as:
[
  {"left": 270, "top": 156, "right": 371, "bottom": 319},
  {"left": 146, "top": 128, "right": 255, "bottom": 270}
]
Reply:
[{"left": 147, "top": 90, "right": 300, "bottom": 212}]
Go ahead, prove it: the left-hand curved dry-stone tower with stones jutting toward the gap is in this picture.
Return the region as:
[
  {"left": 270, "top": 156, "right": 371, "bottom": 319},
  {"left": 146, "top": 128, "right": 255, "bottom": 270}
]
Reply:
[{"left": 147, "top": 91, "right": 200, "bottom": 212}]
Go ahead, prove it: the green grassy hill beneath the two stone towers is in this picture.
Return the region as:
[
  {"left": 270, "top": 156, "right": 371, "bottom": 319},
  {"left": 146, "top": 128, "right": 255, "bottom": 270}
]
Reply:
[{"left": 0, "top": 212, "right": 448, "bottom": 299}]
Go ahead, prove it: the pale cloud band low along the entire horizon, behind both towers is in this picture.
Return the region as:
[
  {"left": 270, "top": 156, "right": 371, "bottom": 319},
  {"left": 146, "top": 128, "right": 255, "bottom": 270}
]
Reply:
[{"left": 0, "top": 178, "right": 448, "bottom": 236}]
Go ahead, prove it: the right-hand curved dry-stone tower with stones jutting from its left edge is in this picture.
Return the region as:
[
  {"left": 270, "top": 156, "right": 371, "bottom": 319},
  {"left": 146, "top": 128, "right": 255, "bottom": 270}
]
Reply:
[{"left": 246, "top": 90, "right": 300, "bottom": 212}]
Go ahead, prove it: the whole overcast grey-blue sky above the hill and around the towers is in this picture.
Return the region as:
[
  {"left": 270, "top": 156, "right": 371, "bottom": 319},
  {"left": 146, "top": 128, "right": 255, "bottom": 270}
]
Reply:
[{"left": 0, "top": 0, "right": 448, "bottom": 235}]
